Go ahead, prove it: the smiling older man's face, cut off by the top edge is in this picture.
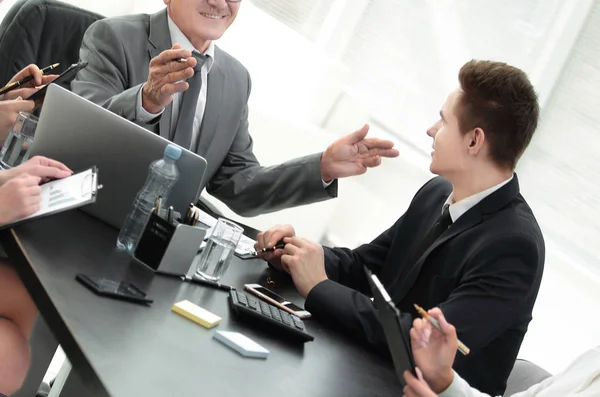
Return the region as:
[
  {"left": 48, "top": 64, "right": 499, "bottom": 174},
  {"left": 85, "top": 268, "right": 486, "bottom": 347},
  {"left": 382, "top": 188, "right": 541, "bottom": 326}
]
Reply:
[{"left": 163, "top": 0, "right": 240, "bottom": 45}]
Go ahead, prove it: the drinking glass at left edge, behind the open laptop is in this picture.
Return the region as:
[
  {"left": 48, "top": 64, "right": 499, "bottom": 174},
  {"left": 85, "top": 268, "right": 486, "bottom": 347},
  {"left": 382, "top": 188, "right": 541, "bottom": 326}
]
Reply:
[{"left": 0, "top": 112, "right": 38, "bottom": 168}]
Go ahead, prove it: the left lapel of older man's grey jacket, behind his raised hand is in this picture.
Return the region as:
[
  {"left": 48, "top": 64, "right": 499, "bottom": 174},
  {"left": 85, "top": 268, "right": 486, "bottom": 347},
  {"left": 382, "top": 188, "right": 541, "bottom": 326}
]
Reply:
[{"left": 148, "top": 8, "right": 173, "bottom": 139}]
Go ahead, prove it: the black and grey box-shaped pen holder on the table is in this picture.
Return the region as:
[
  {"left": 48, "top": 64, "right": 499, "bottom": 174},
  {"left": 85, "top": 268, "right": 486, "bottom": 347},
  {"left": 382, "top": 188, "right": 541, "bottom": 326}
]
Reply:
[{"left": 133, "top": 212, "right": 206, "bottom": 276}]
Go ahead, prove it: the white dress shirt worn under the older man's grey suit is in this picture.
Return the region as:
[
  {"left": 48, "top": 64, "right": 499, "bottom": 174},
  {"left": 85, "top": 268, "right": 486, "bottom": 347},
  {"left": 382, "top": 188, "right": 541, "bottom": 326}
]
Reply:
[{"left": 136, "top": 17, "right": 215, "bottom": 152}]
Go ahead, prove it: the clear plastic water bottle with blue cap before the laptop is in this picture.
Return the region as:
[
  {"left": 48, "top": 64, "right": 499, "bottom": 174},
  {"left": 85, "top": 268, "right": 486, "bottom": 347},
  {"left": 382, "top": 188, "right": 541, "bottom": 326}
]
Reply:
[{"left": 117, "top": 145, "right": 181, "bottom": 254}]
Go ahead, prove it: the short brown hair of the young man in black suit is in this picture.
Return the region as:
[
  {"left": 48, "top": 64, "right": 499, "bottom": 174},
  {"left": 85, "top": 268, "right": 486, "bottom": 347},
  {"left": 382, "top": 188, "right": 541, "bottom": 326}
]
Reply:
[{"left": 455, "top": 60, "right": 540, "bottom": 169}]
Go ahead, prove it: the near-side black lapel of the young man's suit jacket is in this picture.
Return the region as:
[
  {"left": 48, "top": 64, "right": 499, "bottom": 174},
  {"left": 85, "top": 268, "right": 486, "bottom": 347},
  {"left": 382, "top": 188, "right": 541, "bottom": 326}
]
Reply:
[{"left": 392, "top": 174, "right": 519, "bottom": 302}]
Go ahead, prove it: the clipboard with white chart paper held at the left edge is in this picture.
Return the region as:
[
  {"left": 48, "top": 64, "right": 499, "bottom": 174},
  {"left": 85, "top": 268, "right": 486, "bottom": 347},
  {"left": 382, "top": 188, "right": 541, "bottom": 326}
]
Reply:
[{"left": 0, "top": 166, "right": 102, "bottom": 230}]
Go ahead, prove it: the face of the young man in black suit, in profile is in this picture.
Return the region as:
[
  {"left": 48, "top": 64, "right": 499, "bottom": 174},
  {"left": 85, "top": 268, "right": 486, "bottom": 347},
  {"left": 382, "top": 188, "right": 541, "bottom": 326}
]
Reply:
[{"left": 427, "top": 89, "right": 470, "bottom": 179}]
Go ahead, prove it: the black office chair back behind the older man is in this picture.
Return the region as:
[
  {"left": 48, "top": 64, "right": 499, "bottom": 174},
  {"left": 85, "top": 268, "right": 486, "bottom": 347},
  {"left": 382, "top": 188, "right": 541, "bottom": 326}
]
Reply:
[{"left": 0, "top": 0, "right": 104, "bottom": 88}]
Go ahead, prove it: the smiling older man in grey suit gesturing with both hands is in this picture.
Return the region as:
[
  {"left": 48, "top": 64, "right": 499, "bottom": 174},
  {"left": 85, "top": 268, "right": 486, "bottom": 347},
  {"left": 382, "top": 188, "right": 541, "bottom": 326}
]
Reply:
[{"left": 71, "top": 0, "right": 398, "bottom": 216}]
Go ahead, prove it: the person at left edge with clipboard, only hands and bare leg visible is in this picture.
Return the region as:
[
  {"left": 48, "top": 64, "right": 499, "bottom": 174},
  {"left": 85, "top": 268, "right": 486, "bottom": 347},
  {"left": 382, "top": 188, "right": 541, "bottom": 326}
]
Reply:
[{"left": 0, "top": 156, "right": 72, "bottom": 396}]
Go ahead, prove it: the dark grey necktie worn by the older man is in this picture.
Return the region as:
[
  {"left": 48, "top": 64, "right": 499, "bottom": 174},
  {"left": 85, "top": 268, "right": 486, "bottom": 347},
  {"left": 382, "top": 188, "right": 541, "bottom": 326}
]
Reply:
[{"left": 173, "top": 51, "right": 207, "bottom": 149}]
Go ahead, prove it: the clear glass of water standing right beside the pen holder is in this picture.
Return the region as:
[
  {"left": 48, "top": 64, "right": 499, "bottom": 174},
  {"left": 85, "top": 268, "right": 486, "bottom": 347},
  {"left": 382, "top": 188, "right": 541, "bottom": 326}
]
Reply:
[{"left": 196, "top": 218, "right": 244, "bottom": 281}]
